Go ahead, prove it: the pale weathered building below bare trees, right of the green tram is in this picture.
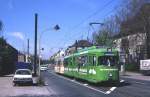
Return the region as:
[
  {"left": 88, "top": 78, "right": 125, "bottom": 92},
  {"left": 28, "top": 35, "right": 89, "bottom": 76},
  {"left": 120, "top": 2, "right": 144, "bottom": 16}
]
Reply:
[{"left": 114, "top": 33, "right": 147, "bottom": 69}]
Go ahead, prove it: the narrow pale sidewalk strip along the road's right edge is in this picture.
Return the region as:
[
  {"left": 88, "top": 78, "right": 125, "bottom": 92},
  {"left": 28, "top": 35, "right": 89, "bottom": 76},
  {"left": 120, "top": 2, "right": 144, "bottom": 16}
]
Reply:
[{"left": 120, "top": 71, "right": 150, "bottom": 81}]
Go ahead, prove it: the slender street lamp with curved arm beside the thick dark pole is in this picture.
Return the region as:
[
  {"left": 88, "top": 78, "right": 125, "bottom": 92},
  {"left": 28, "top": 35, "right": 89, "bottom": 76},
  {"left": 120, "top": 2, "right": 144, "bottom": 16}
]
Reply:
[{"left": 39, "top": 24, "right": 60, "bottom": 75}]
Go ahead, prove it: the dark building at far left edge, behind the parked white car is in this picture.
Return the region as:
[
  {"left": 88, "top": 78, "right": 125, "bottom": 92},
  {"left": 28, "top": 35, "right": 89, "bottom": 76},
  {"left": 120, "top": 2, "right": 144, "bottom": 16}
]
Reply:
[{"left": 0, "top": 38, "right": 18, "bottom": 75}]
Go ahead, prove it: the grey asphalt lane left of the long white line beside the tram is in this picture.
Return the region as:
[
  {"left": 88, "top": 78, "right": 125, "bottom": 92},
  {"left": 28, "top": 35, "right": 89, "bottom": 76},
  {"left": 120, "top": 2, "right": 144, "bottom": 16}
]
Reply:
[{"left": 42, "top": 72, "right": 107, "bottom": 97}]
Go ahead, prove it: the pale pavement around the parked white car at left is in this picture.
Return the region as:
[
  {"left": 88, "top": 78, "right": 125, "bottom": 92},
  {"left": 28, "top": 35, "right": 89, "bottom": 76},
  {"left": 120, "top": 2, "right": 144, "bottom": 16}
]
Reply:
[{"left": 0, "top": 74, "right": 50, "bottom": 97}]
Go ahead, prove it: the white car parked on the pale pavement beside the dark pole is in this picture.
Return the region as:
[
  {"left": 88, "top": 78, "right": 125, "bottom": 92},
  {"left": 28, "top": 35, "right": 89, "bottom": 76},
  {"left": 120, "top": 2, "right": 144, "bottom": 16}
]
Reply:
[{"left": 13, "top": 69, "right": 33, "bottom": 85}]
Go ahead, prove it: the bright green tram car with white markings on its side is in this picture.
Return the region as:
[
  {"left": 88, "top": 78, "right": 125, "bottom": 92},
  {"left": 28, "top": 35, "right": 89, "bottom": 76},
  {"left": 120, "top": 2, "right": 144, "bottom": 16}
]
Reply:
[{"left": 64, "top": 46, "right": 119, "bottom": 83}]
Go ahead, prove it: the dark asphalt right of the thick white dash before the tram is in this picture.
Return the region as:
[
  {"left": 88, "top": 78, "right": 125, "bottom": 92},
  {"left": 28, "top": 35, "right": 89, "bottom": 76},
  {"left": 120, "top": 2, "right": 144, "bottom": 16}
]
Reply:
[{"left": 111, "top": 77, "right": 150, "bottom": 97}]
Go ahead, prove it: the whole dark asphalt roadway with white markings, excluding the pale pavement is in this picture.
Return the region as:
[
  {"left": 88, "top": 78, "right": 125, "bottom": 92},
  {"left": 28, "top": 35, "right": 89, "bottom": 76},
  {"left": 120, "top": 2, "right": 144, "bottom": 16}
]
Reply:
[{"left": 42, "top": 71, "right": 150, "bottom": 97}]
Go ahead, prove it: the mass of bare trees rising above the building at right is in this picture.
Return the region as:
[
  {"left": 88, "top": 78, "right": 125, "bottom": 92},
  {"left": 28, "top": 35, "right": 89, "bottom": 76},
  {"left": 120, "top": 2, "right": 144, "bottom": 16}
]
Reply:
[{"left": 93, "top": 0, "right": 150, "bottom": 58}]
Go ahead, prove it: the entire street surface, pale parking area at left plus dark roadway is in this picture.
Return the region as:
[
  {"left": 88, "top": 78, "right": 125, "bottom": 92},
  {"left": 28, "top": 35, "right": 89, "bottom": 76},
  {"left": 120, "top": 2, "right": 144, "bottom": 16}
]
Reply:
[{"left": 0, "top": 70, "right": 150, "bottom": 97}]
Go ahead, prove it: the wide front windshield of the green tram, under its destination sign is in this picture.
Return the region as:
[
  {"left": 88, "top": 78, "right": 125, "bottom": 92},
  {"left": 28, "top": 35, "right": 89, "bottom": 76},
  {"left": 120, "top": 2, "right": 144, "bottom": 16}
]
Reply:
[{"left": 98, "top": 56, "right": 117, "bottom": 66}]
